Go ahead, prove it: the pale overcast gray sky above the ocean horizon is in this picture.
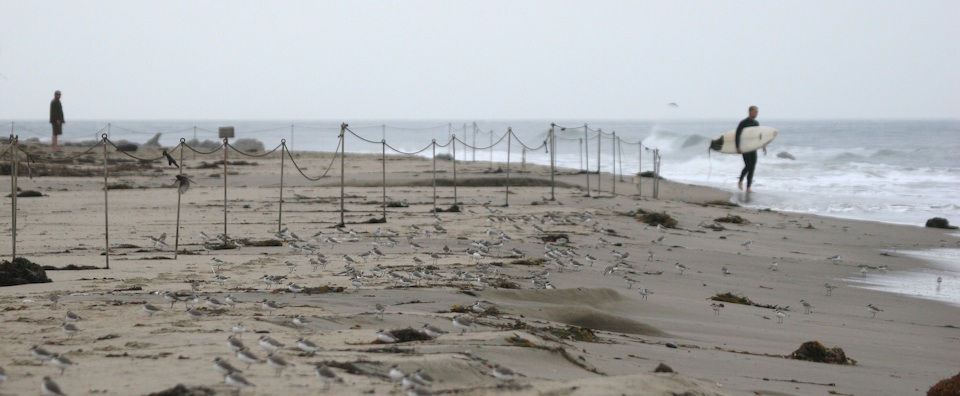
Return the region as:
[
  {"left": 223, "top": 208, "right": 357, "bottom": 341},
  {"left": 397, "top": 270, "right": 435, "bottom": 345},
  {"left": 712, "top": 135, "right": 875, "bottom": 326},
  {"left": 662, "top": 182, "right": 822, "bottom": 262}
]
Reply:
[{"left": 0, "top": 0, "right": 960, "bottom": 122}]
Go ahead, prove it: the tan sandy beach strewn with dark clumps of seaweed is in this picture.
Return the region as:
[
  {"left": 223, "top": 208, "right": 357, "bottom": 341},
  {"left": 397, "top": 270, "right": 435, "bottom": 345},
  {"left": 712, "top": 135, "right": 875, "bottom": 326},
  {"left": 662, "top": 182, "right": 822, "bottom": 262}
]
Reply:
[{"left": 0, "top": 144, "right": 960, "bottom": 395}]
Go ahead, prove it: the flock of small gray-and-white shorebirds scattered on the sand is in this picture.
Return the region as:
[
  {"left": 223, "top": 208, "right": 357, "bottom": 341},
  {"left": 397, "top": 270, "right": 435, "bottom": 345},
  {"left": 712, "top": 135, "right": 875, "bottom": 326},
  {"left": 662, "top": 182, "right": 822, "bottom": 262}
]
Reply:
[{"left": 0, "top": 191, "right": 942, "bottom": 395}]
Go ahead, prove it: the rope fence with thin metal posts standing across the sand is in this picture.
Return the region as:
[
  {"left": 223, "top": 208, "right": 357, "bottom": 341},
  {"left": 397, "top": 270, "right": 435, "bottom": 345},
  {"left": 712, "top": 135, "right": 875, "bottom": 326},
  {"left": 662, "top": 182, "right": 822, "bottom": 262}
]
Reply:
[{"left": 0, "top": 122, "right": 660, "bottom": 269}]
